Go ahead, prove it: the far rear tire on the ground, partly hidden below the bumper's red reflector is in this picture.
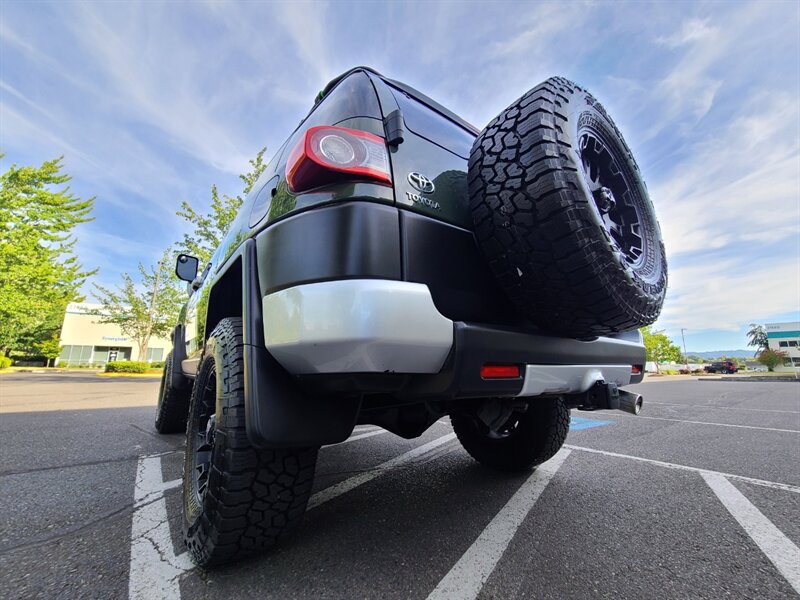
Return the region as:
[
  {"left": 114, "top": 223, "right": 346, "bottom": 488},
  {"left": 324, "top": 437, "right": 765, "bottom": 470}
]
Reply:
[{"left": 450, "top": 398, "right": 570, "bottom": 471}]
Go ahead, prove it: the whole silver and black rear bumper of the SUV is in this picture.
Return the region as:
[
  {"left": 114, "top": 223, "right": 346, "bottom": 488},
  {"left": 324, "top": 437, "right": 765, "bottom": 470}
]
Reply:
[{"left": 262, "top": 279, "right": 645, "bottom": 400}]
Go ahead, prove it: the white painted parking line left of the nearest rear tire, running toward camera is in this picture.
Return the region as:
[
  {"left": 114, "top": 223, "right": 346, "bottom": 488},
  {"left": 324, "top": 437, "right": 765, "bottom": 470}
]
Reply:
[{"left": 128, "top": 454, "right": 194, "bottom": 600}]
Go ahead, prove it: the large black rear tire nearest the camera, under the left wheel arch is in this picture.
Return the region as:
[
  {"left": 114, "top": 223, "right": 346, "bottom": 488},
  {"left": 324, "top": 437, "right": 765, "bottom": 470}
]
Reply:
[{"left": 183, "top": 318, "right": 318, "bottom": 567}]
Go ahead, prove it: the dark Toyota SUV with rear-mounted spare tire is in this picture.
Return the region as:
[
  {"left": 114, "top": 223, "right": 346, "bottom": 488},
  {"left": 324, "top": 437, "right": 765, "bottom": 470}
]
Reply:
[{"left": 156, "top": 67, "right": 666, "bottom": 566}]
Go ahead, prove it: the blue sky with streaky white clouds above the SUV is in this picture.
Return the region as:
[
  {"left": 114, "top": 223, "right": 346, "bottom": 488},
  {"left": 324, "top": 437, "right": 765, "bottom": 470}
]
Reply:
[{"left": 0, "top": 0, "right": 800, "bottom": 351}]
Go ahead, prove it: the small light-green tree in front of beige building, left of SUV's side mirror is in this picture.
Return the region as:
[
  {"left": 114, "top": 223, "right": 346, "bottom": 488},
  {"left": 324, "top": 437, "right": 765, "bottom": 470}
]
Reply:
[{"left": 92, "top": 249, "right": 185, "bottom": 360}]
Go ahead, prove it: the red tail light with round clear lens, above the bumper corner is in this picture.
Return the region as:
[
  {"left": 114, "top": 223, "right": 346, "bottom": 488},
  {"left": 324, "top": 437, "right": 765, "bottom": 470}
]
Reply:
[{"left": 286, "top": 125, "right": 392, "bottom": 193}]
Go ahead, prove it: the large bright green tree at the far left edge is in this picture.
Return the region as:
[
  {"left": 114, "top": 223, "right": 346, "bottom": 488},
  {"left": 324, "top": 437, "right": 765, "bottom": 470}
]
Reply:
[{"left": 0, "top": 155, "right": 96, "bottom": 354}]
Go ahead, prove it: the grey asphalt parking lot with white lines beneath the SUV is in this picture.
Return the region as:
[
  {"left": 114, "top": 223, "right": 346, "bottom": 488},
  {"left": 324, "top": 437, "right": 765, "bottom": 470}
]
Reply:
[{"left": 0, "top": 374, "right": 800, "bottom": 600}]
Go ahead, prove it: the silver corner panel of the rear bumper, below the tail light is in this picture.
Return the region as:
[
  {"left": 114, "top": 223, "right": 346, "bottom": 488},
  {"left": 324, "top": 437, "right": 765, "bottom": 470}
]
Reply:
[{"left": 263, "top": 279, "right": 453, "bottom": 375}]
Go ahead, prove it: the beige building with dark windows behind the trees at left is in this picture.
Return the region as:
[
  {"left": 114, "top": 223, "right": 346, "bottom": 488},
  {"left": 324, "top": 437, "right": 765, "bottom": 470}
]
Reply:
[{"left": 56, "top": 303, "right": 172, "bottom": 367}]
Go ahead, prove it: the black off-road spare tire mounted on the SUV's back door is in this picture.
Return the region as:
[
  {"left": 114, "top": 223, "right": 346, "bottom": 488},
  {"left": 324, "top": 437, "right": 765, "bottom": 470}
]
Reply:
[{"left": 468, "top": 77, "right": 667, "bottom": 338}]
